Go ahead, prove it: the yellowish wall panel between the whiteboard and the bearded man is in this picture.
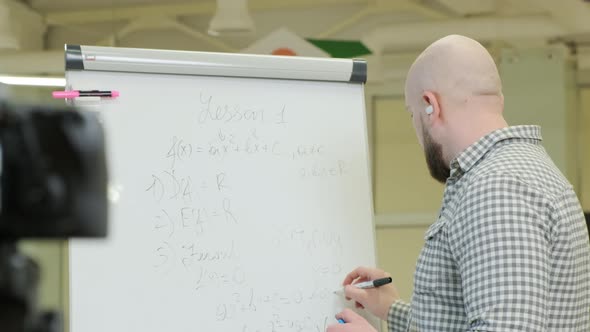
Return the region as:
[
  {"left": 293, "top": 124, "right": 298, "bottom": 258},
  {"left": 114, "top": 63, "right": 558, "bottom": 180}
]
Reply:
[{"left": 372, "top": 95, "right": 443, "bottom": 300}]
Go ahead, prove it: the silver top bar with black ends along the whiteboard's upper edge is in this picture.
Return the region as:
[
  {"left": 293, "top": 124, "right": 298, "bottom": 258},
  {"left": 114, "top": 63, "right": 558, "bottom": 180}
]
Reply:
[{"left": 65, "top": 44, "right": 367, "bottom": 83}]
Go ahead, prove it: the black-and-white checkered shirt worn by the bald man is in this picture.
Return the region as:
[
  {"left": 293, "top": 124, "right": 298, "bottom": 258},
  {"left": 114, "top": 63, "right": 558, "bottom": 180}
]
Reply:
[{"left": 388, "top": 126, "right": 590, "bottom": 332}]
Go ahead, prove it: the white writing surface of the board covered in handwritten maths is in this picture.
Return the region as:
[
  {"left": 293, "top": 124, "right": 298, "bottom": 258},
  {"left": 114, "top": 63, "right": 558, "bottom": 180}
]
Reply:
[{"left": 67, "top": 71, "right": 378, "bottom": 332}]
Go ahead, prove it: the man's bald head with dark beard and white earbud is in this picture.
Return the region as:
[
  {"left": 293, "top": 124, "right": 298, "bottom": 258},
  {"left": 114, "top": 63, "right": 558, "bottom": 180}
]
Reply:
[{"left": 405, "top": 35, "right": 507, "bottom": 183}]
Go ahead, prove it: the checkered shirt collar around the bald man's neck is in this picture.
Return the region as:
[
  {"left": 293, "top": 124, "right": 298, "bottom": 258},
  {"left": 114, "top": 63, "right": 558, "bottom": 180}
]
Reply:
[{"left": 451, "top": 126, "right": 542, "bottom": 176}]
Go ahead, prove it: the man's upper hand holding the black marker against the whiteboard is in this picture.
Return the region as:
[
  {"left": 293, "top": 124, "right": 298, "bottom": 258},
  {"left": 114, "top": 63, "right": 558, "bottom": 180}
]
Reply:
[{"left": 342, "top": 267, "right": 399, "bottom": 320}]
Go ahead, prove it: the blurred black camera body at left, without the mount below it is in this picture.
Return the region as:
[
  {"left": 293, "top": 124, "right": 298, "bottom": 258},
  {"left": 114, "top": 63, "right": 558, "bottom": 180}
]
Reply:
[{"left": 0, "top": 103, "right": 107, "bottom": 240}]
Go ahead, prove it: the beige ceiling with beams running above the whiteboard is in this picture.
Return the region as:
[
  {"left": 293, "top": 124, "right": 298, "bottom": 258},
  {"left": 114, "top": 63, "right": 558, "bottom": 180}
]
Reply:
[{"left": 0, "top": 0, "right": 590, "bottom": 76}]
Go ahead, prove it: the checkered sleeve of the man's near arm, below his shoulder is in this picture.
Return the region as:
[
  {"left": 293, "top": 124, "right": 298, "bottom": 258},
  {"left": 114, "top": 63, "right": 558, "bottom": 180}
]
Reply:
[{"left": 449, "top": 175, "right": 550, "bottom": 331}]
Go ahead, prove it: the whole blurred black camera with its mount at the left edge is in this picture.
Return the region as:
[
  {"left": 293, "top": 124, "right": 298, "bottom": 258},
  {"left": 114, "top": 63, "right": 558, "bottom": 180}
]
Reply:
[{"left": 0, "top": 100, "right": 108, "bottom": 332}]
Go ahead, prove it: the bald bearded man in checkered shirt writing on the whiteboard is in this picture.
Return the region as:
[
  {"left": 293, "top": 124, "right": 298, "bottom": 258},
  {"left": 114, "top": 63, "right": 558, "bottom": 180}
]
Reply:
[{"left": 328, "top": 35, "right": 590, "bottom": 332}]
